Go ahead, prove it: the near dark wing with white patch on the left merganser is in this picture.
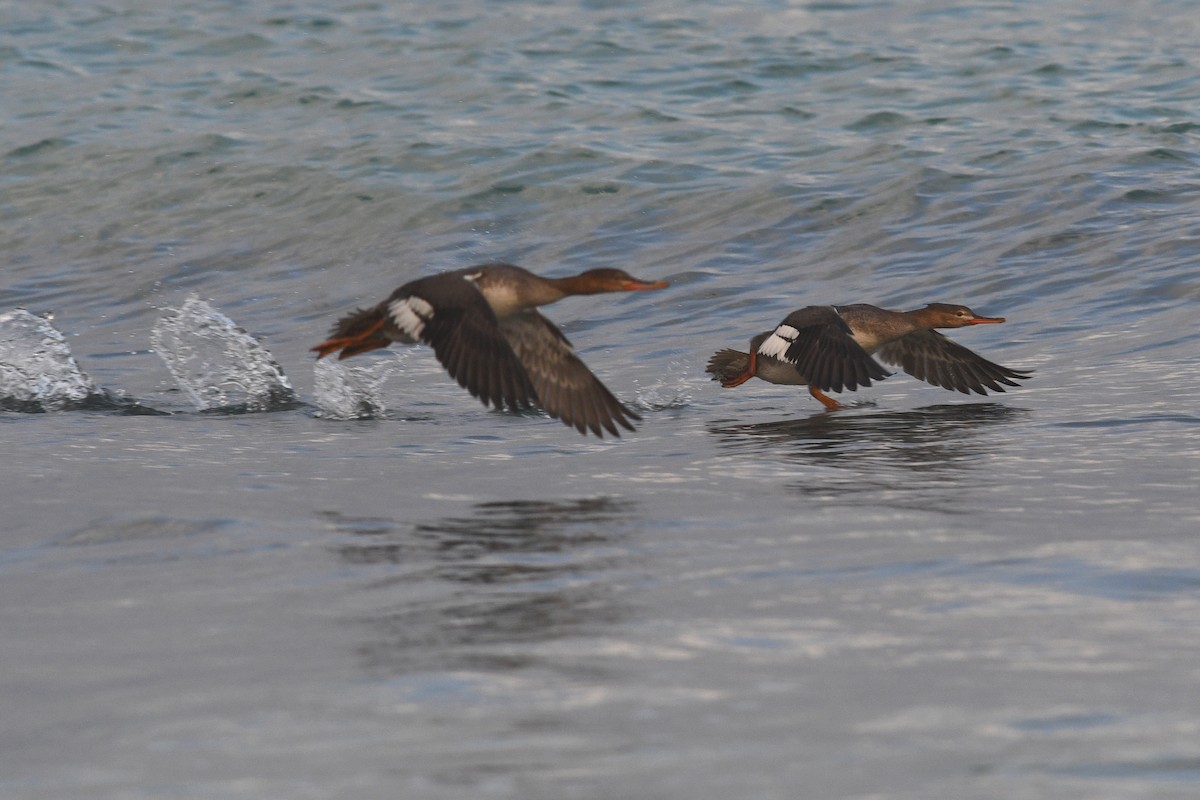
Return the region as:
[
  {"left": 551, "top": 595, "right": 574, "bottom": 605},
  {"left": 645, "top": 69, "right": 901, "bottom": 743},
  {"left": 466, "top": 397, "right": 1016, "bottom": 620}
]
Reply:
[{"left": 396, "top": 272, "right": 538, "bottom": 411}]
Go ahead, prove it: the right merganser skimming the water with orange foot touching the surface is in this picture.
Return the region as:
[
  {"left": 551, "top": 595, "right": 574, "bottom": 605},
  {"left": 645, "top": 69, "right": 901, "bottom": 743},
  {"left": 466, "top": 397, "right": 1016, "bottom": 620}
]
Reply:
[{"left": 707, "top": 302, "right": 1032, "bottom": 410}]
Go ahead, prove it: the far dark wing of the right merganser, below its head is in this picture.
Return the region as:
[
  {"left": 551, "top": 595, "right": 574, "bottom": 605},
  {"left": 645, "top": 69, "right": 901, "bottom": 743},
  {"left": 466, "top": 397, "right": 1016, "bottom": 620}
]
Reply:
[{"left": 878, "top": 331, "right": 1032, "bottom": 395}]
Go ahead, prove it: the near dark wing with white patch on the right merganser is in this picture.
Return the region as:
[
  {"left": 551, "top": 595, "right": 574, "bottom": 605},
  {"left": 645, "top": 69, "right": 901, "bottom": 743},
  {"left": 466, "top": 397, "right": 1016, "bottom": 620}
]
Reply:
[{"left": 758, "top": 306, "right": 888, "bottom": 392}]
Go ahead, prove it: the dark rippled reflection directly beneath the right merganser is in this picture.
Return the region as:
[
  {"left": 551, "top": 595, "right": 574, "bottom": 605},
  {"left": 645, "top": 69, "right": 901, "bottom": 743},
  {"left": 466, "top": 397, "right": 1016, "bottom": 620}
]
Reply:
[{"left": 708, "top": 403, "right": 1027, "bottom": 511}]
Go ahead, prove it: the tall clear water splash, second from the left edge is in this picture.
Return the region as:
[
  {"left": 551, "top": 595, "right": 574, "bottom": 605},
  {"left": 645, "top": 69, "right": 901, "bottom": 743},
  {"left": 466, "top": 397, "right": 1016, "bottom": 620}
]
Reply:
[{"left": 150, "top": 295, "right": 298, "bottom": 414}]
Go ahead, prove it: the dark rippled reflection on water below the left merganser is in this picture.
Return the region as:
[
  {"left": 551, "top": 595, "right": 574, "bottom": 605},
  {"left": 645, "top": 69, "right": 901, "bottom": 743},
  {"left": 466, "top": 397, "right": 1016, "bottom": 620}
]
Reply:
[{"left": 326, "top": 498, "right": 634, "bottom": 673}]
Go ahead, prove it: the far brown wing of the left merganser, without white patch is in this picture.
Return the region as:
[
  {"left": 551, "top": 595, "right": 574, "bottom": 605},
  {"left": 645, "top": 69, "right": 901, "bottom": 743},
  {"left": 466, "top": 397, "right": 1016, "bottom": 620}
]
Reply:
[{"left": 500, "top": 309, "right": 642, "bottom": 437}]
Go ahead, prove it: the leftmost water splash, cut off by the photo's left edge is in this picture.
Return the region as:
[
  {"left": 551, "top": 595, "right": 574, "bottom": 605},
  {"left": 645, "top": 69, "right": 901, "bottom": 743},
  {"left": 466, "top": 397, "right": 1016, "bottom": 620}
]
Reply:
[{"left": 0, "top": 308, "right": 101, "bottom": 411}]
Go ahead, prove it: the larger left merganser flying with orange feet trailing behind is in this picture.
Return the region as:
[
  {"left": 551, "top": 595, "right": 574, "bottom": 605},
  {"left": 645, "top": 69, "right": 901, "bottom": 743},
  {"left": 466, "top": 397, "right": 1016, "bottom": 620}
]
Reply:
[{"left": 312, "top": 264, "right": 667, "bottom": 437}]
